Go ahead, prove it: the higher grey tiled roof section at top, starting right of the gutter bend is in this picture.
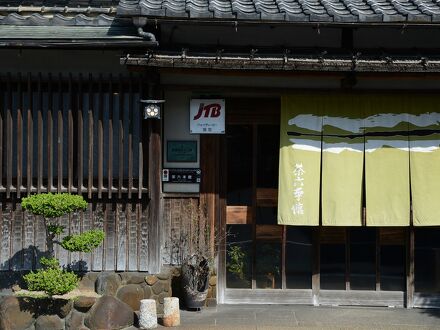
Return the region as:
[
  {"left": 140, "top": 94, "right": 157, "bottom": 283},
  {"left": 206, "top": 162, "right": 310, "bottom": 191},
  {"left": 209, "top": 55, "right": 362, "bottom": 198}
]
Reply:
[{"left": 117, "top": 0, "right": 440, "bottom": 23}]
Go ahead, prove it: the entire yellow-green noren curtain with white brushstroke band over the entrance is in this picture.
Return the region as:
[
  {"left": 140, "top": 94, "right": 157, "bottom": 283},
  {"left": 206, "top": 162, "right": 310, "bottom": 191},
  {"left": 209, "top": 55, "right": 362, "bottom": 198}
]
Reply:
[{"left": 278, "top": 94, "right": 440, "bottom": 226}]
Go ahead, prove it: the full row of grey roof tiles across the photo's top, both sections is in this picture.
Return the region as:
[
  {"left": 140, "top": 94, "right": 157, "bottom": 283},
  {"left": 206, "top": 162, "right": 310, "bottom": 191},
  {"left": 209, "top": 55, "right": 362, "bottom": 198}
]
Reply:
[{"left": 8, "top": 0, "right": 440, "bottom": 26}]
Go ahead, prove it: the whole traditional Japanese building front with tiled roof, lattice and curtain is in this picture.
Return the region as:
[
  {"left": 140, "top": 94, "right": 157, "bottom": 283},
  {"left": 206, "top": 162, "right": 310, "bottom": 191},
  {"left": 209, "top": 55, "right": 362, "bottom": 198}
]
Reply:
[{"left": 0, "top": 0, "right": 440, "bottom": 307}]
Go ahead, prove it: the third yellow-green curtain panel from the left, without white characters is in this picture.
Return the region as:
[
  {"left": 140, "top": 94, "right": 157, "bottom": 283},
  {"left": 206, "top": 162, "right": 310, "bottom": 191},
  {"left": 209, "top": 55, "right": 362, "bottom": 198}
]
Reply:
[{"left": 365, "top": 95, "right": 410, "bottom": 226}]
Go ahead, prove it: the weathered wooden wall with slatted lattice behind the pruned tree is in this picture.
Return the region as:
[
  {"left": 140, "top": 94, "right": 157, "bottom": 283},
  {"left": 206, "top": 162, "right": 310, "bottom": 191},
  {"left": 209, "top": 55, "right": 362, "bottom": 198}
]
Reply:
[{"left": 0, "top": 73, "right": 160, "bottom": 271}]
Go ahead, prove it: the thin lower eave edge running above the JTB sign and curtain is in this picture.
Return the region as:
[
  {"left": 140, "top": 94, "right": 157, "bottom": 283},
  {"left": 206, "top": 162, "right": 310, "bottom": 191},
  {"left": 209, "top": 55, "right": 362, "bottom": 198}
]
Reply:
[{"left": 120, "top": 53, "right": 440, "bottom": 73}]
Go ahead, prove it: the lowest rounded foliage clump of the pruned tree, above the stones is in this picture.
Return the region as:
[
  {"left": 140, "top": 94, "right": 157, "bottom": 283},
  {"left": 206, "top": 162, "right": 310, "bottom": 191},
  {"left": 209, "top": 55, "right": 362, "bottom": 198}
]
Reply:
[{"left": 23, "top": 268, "right": 78, "bottom": 295}]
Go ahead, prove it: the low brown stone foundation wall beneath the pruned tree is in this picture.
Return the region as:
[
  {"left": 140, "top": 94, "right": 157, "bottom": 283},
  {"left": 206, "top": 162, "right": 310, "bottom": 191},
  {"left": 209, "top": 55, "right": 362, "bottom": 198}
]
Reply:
[{"left": 0, "top": 268, "right": 176, "bottom": 330}]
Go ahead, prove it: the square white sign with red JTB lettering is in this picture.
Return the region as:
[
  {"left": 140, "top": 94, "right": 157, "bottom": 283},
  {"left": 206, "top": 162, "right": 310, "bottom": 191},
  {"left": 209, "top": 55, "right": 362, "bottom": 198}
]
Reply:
[{"left": 189, "top": 99, "right": 225, "bottom": 134}]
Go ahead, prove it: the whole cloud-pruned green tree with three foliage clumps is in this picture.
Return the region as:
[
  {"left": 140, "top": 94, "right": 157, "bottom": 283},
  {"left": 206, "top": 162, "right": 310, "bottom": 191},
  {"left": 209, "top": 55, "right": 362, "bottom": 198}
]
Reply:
[{"left": 21, "top": 193, "right": 105, "bottom": 295}]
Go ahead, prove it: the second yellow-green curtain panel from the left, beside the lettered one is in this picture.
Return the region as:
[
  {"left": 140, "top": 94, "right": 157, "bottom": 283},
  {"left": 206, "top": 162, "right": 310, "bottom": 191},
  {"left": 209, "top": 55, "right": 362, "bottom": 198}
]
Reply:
[{"left": 321, "top": 95, "right": 364, "bottom": 226}]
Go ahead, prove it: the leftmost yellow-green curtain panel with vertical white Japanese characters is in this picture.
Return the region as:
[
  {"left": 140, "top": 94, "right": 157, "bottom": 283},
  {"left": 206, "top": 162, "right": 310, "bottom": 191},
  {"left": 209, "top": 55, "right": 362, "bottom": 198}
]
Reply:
[{"left": 278, "top": 95, "right": 322, "bottom": 226}]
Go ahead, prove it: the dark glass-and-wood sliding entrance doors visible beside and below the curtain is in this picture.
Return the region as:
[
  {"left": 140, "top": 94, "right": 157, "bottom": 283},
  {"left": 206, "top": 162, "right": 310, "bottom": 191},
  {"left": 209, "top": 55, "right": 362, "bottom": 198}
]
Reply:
[{"left": 219, "top": 100, "right": 408, "bottom": 307}]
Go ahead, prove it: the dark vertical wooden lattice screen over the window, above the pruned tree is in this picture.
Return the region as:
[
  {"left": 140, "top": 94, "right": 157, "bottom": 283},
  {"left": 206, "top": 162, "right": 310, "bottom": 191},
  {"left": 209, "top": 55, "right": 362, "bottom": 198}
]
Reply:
[{"left": 0, "top": 73, "right": 147, "bottom": 199}]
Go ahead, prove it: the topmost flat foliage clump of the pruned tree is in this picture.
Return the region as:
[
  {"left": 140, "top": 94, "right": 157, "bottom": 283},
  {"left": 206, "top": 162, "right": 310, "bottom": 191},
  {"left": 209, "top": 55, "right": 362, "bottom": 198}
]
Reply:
[{"left": 21, "top": 193, "right": 87, "bottom": 219}]
